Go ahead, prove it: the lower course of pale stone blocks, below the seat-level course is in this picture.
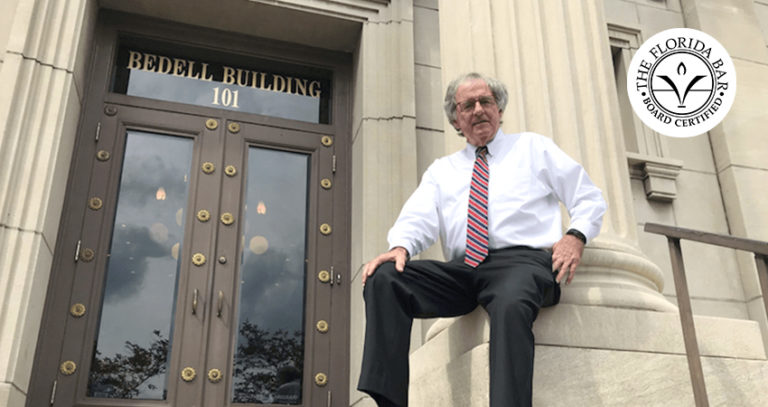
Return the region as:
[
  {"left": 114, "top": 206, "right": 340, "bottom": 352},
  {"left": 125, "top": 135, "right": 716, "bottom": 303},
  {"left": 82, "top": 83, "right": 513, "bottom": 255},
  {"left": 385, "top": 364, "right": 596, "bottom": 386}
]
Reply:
[{"left": 409, "top": 343, "right": 768, "bottom": 407}]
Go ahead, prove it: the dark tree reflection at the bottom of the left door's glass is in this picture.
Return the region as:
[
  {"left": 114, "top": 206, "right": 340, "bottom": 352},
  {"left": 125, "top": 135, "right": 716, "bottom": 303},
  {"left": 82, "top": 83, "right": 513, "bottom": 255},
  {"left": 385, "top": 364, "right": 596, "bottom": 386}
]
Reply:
[{"left": 89, "top": 330, "right": 168, "bottom": 399}]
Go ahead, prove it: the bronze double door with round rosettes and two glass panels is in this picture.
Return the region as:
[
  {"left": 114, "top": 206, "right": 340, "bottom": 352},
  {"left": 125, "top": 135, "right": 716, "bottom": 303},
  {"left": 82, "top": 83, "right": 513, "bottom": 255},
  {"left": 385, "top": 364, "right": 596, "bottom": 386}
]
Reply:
[{"left": 38, "top": 104, "right": 348, "bottom": 406}]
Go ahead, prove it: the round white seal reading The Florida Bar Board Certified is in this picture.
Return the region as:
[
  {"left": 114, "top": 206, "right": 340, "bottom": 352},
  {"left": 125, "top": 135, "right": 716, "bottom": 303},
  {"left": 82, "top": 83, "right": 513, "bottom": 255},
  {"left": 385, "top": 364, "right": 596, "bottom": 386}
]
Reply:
[{"left": 627, "top": 28, "right": 736, "bottom": 137}]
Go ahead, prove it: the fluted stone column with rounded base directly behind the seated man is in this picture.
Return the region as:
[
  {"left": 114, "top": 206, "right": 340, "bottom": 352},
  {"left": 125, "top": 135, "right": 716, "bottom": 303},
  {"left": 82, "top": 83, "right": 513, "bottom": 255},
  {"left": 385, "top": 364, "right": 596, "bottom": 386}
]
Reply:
[{"left": 440, "top": 0, "right": 676, "bottom": 311}]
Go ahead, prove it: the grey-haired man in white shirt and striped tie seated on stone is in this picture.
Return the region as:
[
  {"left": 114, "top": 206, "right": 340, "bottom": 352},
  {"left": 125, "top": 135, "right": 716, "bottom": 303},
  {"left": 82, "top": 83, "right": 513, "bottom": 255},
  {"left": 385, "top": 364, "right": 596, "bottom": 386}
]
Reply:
[{"left": 358, "top": 73, "right": 605, "bottom": 407}]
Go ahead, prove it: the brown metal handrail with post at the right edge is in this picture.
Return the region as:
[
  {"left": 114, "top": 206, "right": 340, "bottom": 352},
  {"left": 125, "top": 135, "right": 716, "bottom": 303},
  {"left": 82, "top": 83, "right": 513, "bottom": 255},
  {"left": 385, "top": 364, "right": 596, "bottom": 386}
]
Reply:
[{"left": 644, "top": 223, "right": 768, "bottom": 407}]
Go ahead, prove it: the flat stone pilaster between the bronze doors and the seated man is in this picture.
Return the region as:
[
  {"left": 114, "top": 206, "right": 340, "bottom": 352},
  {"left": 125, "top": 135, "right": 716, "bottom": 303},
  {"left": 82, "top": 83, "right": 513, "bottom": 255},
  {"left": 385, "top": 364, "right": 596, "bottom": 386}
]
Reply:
[{"left": 350, "top": 0, "right": 418, "bottom": 406}]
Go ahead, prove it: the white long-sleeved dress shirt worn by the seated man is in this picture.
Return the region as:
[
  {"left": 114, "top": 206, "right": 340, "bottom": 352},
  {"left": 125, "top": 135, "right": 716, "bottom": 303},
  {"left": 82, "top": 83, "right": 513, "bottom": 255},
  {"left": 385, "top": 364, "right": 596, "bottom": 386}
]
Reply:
[{"left": 387, "top": 130, "right": 606, "bottom": 260}]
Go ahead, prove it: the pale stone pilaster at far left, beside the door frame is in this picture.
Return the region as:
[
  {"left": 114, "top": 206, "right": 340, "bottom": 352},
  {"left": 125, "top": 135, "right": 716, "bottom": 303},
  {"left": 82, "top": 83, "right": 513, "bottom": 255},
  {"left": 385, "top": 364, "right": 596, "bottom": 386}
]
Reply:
[{"left": 0, "top": 0, "right": 96, "bottom": 407}]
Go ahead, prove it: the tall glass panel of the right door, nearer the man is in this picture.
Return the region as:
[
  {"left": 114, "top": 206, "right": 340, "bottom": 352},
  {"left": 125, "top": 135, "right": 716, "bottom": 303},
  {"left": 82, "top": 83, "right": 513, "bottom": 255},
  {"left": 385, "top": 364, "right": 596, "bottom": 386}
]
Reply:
[{"left": 233, "top": 147, "right": 309, "bottom": 404}]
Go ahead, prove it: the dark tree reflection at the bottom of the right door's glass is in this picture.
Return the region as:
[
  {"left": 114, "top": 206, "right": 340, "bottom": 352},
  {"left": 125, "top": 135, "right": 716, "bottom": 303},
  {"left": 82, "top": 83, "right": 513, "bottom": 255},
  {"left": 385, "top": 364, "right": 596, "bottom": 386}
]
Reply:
[{"left": 233, "top": 320, "right": 304, "bottom": 404}]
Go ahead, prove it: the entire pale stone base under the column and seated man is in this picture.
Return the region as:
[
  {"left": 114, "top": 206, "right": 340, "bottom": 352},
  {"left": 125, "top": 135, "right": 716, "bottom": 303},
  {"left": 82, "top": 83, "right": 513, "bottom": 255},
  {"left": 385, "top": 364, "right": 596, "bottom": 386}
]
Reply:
[{"left": 409, "top": 304, "right": 768, "bottom": 407}]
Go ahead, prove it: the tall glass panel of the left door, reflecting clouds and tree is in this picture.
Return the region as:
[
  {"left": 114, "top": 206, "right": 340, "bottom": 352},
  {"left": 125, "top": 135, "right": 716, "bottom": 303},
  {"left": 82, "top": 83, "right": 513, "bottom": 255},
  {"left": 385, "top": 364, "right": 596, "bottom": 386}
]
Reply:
[{"left": 88, "top": 131, "right": 193, "bottom": 399}]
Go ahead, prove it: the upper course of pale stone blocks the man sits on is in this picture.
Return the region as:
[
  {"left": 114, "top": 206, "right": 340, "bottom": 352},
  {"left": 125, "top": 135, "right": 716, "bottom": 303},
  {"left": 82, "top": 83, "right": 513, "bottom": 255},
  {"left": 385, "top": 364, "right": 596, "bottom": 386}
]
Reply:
[{"left": 411, "top": 304, "right": 766, "bottom": 378}]
